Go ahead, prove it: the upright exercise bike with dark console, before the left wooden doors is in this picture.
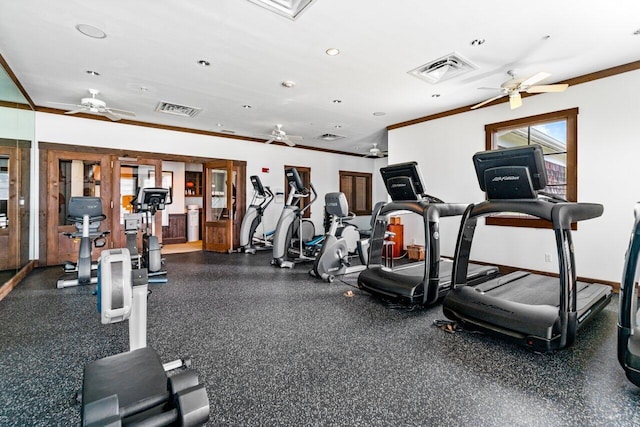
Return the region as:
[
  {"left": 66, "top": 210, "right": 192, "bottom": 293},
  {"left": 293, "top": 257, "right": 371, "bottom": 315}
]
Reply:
[{"left": 124, "top": 187, "right": 172, "bottom": 276}]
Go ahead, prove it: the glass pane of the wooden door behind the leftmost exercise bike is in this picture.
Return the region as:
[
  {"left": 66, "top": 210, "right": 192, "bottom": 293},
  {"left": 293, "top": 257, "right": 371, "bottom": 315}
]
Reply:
[{"left": 58, "top": 160, "right": 100, "bottom": 225}]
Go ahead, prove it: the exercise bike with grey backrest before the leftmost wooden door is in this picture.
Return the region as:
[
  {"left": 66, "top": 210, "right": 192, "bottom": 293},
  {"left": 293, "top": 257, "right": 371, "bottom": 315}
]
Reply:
[{"left": 56, "top": 197, "right": 109, "bottom": 288}]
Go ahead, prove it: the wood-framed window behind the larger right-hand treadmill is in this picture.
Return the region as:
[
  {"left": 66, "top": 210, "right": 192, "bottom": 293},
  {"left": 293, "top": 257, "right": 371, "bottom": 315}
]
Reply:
[{"left": 485, "top": 108, "right": 578, "bottom": 228}]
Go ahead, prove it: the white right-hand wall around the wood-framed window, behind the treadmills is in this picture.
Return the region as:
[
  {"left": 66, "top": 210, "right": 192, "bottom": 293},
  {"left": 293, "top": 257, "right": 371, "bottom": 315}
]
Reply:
[{"left": 389, "top": 71, "right": 640, "bottom": 282}]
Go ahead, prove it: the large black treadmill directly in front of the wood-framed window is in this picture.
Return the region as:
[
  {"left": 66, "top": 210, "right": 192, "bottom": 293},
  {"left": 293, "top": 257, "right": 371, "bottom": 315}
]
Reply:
[{"left": 442, "top": 145, "right": 612, "bottom": 351}]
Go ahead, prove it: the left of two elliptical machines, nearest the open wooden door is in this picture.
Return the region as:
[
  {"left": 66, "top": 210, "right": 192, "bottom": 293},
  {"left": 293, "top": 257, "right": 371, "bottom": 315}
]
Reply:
[{"left": 238, "top": 175, "right": 274, "bottom": 254}]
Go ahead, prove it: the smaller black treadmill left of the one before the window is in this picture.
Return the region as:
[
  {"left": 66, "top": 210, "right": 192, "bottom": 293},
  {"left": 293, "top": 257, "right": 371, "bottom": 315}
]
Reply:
[{"left": 358, "top": 162, "right": 498, "bottom": 306}]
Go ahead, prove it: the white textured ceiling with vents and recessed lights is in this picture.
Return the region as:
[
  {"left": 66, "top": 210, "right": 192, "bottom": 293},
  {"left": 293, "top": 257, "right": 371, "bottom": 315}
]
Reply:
[{"left": 0, "top": 0, "right": 640, "bottom": 153}]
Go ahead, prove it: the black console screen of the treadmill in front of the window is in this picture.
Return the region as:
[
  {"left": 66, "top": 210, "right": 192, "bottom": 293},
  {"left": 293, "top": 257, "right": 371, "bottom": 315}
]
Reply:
[{"left": 473, "top": 145, "right": 547, "bottom": 199}]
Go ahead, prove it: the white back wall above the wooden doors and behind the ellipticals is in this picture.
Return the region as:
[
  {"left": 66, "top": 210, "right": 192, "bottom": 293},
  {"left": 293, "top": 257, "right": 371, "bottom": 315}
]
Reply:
[{"left": 32, "top": 113, "right": 386, "bottom": 257}]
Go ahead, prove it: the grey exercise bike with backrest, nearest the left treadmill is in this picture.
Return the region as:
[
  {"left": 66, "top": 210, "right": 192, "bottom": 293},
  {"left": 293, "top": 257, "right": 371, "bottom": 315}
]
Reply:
[{"left": 309, "top": 192, "right": 369, "bottom": 283}]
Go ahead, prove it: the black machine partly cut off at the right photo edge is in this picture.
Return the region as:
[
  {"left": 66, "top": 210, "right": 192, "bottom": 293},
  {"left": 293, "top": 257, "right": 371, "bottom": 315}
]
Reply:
[{"left": 618, "top": 203, "right": 640, "bottom": 387}]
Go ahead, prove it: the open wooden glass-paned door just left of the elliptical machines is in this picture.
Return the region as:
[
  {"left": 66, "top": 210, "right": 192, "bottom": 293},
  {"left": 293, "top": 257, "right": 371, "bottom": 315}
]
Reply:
[{"left": 202, "top": 160, "right": 246, "bottom": 252}]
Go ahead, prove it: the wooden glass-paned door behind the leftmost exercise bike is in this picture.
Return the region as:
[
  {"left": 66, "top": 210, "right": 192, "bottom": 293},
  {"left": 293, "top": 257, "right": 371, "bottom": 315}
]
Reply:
[{"left": 46, "top": 150, "right": 113, "bottom": 265}]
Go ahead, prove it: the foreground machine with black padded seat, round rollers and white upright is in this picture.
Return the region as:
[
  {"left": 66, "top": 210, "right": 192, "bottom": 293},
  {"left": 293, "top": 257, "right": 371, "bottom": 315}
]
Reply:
[{"left": 78, "top": 248, "right": 209, "bottom": 426}]
